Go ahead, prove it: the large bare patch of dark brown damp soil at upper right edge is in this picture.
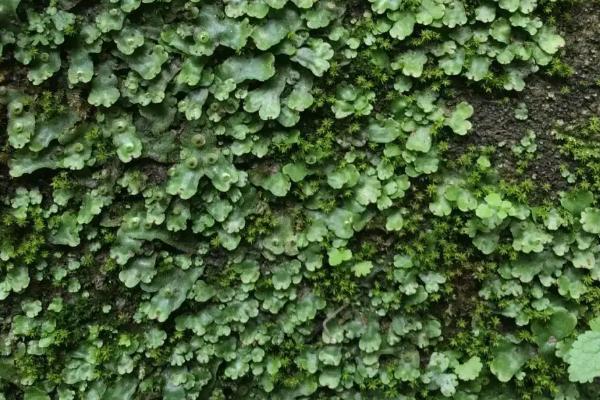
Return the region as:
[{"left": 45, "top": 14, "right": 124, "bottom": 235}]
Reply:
[{"left": 448, "top": 1, "right": 600, "bottom": 200}]
